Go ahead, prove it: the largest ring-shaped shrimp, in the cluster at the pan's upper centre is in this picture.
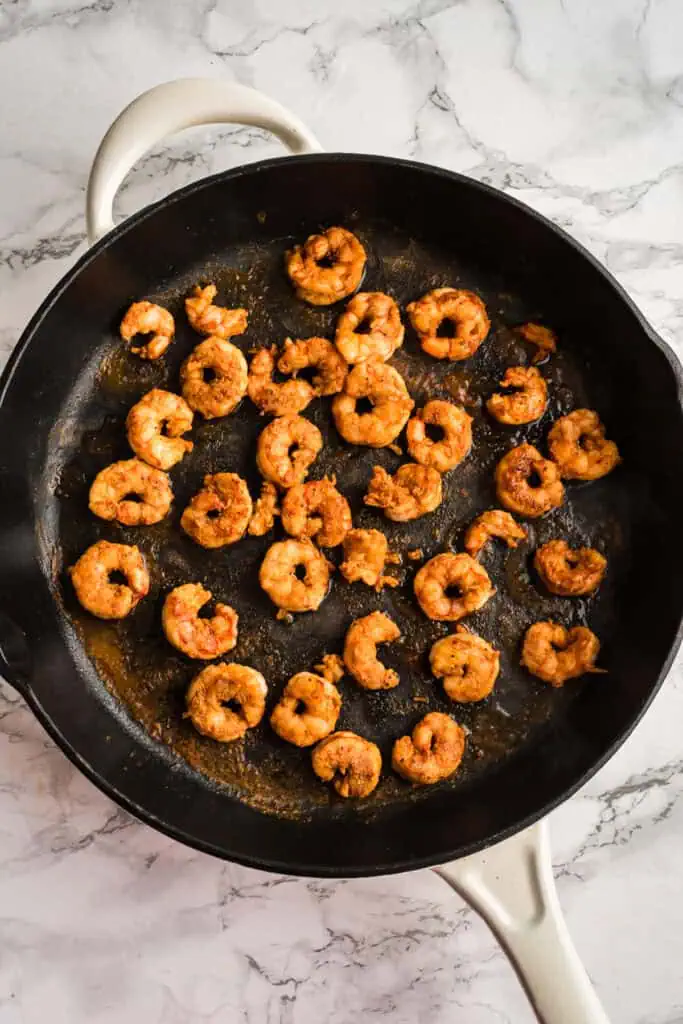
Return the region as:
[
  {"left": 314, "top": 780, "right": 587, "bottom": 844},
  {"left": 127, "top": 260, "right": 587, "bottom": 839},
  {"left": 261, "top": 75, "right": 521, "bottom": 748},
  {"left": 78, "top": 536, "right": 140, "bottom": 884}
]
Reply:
[{"left": 332, "top": 359, "right": 415, "bottom": 447}]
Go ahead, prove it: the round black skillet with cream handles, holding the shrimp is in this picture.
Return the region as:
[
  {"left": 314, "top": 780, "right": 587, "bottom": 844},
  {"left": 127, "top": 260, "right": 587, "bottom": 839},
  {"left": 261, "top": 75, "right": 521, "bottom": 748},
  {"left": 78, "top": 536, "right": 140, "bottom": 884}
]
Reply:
[{"left": 0, "top": 80, "right": 683, "bottom": 1022}]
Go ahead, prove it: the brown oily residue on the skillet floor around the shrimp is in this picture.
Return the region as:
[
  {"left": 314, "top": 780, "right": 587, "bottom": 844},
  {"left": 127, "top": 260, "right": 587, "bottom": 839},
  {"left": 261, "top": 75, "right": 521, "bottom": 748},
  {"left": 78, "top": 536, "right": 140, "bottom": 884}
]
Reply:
[{"left": 50, "top": 224, "right": 632, "bottom": 817}]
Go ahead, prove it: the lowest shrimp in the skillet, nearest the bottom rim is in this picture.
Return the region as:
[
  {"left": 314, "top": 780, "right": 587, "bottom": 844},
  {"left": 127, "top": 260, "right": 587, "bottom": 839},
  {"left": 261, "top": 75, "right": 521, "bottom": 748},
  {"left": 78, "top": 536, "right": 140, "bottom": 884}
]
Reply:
[{"left": 311, "top": 732, "right": 382, "bottom": 797}]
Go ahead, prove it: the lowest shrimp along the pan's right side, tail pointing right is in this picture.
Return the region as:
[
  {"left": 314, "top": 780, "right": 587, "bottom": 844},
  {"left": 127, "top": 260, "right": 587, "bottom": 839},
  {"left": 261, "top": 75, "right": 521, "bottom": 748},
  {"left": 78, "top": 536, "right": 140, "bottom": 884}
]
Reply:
[{"left": 521, "top": 622, "right": 604, "bottom": 686}]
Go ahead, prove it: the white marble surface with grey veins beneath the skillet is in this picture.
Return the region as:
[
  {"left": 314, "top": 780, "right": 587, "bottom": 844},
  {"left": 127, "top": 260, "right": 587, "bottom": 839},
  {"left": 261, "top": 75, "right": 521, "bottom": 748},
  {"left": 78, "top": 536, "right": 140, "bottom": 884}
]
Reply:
[{"left": 0, "top": 0, "right": 683, "bottom": 1024}]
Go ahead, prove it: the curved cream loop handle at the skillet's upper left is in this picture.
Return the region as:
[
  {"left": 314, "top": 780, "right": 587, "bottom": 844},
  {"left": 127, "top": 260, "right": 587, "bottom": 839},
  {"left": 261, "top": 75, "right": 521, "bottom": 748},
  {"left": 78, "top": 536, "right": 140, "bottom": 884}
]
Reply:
[{"left": 86, "top": 78, "right": 321, "bottom": 245}]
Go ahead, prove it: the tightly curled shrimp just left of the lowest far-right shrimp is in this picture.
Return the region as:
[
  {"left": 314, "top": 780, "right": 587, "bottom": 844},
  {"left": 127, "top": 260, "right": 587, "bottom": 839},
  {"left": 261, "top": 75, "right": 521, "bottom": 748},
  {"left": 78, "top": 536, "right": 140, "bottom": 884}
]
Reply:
[{"left": 429, "top": 626, "right": 501, "bottom": 703}]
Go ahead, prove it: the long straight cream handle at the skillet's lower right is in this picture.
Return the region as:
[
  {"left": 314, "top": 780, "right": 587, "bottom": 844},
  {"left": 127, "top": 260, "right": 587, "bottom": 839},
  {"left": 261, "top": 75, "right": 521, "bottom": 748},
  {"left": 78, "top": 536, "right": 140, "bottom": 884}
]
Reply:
[{"left": 436, "top": 821, "right": 609, "bottom": 1024}]
